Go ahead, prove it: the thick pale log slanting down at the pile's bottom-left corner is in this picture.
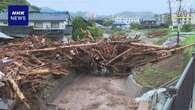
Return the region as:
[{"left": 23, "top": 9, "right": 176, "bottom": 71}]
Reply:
[{"left": 7, "top": 78, "right": 30, "bottom": 109}]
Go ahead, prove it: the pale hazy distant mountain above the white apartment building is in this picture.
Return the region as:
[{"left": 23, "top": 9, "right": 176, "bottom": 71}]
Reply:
[{"left": 114, "top": 11, "right": 155, "bottom": 19}]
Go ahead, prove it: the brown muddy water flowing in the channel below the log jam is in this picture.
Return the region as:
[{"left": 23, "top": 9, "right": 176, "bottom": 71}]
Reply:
[{"left": 53, "top": 75, "right": 139, "bottom": 110}]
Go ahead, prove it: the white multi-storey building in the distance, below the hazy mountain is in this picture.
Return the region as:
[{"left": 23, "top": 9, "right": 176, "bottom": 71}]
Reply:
[{"left": 113, "top": 16, "right": 140, "bottom": 28}]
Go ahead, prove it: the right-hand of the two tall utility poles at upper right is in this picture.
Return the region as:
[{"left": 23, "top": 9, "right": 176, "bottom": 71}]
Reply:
[{"left": 176, "top": 0, "right": 182, "bottom": 45}]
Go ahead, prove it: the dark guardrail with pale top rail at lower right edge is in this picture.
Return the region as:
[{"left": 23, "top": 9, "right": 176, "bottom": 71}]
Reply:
[{"left": 162, "top": 53, "right": 195, "bottom": 110}]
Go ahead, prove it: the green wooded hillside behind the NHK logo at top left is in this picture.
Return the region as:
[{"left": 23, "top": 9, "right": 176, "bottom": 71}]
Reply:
[{"left": 0, "top": 0, "right": 40, "bottom": 12}]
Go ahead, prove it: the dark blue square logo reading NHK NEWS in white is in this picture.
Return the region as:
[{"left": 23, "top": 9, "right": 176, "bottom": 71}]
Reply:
[{"left": 8, "top": 5, "right": 29, "bottom": 26}]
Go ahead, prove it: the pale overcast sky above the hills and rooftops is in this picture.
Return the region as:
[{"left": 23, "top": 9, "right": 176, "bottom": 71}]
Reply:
[{"left": 28, "top": 0, "right": 195, "bottom": 15}]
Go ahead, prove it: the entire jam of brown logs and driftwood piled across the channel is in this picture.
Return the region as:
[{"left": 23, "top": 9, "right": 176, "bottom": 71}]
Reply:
[{"left": 0, "top": 36, "right": 193, "bottom": 108}]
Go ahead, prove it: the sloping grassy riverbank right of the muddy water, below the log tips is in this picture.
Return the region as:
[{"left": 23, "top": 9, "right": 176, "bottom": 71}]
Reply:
[{"left": 135, "top": 56, "right": 183, "bottom": 88}]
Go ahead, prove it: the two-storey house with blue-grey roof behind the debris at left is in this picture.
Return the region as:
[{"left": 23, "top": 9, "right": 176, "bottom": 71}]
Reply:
[{"left": 0, "top": 12, "right": 71, "bottom": 36}]
